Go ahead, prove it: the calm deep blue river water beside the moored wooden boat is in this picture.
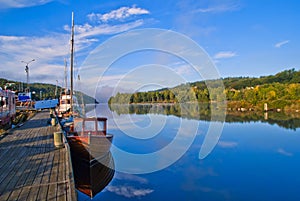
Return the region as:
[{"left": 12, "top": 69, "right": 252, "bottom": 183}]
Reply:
[{"left": 79, "top": 105, "right": 300, "bottom": 201}]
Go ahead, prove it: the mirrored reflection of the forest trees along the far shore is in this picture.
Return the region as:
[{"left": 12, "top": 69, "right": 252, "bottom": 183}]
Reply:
[{"left": 109, "top": 103, "right": 300, "bottom": 130}]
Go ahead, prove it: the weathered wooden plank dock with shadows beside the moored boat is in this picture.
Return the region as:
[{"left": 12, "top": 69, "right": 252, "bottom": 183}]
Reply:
[{"left": 0, "top": 112, "right": 77, "bottom": 201}]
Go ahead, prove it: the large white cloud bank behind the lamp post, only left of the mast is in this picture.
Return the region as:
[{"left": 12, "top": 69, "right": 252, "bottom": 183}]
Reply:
[{"left": 0, "top": 34, "right": 69, "bottom": 83}]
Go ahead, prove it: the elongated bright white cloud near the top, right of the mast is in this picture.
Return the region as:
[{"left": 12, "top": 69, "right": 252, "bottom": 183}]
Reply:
[{"left": 88, "top": 5, "right": 150, "bottom": 22}]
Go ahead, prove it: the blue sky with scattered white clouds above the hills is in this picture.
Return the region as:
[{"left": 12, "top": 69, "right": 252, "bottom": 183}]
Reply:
[{"left": 0, "top": 0, "right": 300, "bottom": 92}]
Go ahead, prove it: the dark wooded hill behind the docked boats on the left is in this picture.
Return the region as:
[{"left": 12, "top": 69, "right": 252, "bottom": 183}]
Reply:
[{"left": 0, "top": 78, "right": 97, "bottom": 104}]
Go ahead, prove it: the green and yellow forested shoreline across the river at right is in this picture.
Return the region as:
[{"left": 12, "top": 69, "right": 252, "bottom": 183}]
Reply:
[{"left": 109, "top": 69, "right": 300, "bottom": 112}]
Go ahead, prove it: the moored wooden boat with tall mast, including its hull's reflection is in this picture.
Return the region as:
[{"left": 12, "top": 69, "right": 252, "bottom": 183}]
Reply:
[{"left": 63, "top": 13, "right": 115, "bottom": 197}]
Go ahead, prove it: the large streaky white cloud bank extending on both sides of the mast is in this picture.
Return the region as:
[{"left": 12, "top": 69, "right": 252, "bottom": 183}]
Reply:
[{"left": 0, "top": 17, "right": 144, "bottom": 83}]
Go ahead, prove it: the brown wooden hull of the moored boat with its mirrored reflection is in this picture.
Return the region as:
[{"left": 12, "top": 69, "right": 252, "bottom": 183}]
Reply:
[{"left": 67, "top": 134, "right": 115, "bottom": 198}]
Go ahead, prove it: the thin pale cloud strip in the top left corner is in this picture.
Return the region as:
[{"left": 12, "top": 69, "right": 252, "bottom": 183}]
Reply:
[{"left": 0, "top": 0, "right": 54, "bottom": 8}]
